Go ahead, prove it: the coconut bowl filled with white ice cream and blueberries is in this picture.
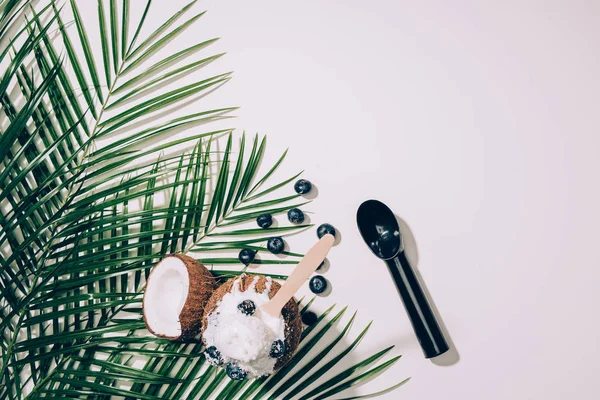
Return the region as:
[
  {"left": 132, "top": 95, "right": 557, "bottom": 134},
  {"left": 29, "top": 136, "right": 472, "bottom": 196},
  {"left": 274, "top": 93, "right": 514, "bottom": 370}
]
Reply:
[{"left": 202, "top": 274, "right": 302, "bottom": 379}]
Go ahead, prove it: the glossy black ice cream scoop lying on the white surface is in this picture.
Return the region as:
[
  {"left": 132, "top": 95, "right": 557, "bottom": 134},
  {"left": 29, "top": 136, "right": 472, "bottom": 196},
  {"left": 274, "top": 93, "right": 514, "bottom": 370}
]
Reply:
[{"left": 356, "top": 200, "right": 448, "bottom": 358}]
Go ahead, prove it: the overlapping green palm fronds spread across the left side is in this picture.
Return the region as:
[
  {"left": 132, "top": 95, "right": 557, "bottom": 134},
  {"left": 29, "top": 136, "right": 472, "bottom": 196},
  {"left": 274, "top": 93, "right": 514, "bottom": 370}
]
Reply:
[{"left": 0, "top": 0, "right": 403, "bottom": 399}]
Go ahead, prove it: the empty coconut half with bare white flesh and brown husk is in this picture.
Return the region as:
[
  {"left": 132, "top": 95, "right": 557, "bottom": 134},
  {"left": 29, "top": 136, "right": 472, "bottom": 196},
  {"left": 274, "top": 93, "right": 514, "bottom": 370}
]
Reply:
[{"left": 143, "top": 254, "right": 217, "bottom": 340}]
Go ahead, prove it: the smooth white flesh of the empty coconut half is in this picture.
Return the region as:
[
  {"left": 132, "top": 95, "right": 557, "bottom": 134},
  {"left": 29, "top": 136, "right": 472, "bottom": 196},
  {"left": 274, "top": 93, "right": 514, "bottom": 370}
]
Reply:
[{"left": 144, "top": 257, "right": 190, "bottom": 337}]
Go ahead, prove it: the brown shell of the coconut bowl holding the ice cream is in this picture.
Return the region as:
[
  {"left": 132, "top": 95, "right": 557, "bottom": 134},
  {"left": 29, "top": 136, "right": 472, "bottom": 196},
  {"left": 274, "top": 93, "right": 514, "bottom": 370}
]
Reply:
[{"left": 202, "top": 274, "right": 302, "bottom": 369}]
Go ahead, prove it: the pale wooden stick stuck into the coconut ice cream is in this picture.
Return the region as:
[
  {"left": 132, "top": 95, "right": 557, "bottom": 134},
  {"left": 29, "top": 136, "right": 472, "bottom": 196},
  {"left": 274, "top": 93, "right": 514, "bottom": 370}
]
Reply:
[{"left": 261, "top": 234, "right": 335, "bottom": 317}]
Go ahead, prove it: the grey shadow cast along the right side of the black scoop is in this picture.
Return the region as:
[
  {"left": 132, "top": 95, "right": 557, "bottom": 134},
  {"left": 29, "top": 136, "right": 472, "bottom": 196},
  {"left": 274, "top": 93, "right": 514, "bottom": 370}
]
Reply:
[{"left": 396, "top": 215, "right": 460, "bottom": 367}]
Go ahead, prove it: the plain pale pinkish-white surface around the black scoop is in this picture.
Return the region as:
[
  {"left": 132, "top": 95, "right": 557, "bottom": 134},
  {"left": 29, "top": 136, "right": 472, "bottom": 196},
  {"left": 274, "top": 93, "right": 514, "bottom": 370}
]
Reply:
[{"left": 86, "top": 0, "right": 600, "bottom": 400}]
